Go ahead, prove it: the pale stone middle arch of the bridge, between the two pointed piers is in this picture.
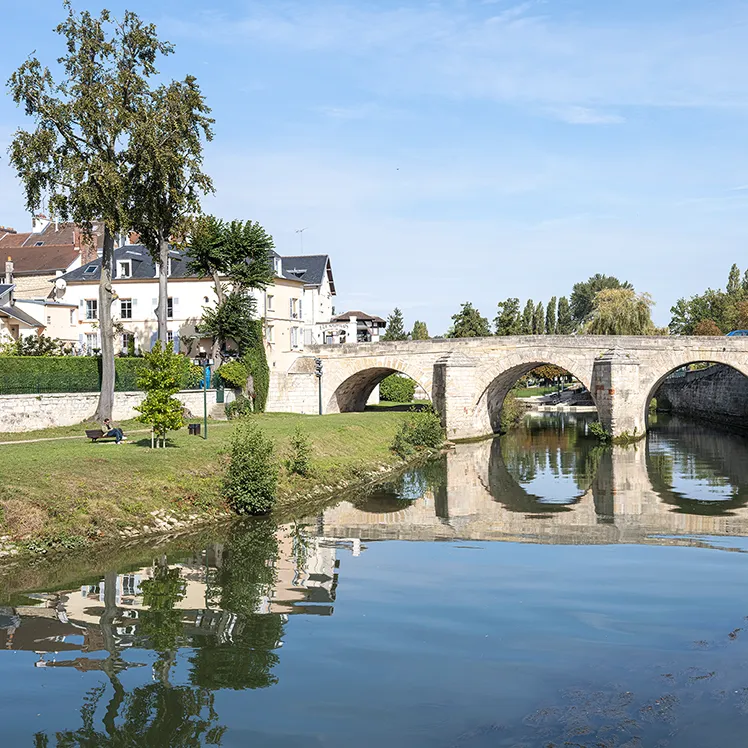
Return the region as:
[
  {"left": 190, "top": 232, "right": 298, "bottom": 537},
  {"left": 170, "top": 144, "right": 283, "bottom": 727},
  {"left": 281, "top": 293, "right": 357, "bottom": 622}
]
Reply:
[{"left": 472, "top": 349, "right": 594, "bottom": 434}]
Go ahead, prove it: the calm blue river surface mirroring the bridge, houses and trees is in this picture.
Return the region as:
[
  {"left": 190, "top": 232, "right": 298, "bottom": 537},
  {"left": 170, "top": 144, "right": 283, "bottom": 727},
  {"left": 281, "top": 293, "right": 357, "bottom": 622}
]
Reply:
[{"left": 0, "top": 416, "right": 748, "bottom": 748}]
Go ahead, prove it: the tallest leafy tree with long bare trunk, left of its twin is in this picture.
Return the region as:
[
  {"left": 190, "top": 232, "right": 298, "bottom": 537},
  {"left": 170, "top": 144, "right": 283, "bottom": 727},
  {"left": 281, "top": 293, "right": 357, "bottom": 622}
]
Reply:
[{"left": 8, "top": 2, "right": 172, "bottom": 419}]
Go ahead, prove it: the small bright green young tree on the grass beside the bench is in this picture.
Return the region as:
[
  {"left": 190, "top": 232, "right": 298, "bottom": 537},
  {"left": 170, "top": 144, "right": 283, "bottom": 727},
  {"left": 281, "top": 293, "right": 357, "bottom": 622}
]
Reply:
[{"left": 136, "top": 341, "right": 184, "bottom": 448}]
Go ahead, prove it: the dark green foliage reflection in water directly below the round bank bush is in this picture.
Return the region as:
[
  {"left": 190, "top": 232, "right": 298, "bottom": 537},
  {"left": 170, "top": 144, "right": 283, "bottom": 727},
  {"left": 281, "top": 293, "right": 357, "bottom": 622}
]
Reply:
[{"left": 190, "top": 518, "right": 284, "bottom": 689}]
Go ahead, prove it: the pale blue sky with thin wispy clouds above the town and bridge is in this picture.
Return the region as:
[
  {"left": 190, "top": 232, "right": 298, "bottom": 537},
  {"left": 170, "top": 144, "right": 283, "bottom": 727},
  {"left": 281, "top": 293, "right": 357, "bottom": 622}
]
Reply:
[{"left": 0, "top": 0, "right": 748, "bottom": 334}]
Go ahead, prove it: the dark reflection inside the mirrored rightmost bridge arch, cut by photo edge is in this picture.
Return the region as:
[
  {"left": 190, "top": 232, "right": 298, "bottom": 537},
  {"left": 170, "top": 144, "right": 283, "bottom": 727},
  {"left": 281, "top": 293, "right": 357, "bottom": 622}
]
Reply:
[{"left": 646, "top": 416, "right": 748, "bottom": 516}]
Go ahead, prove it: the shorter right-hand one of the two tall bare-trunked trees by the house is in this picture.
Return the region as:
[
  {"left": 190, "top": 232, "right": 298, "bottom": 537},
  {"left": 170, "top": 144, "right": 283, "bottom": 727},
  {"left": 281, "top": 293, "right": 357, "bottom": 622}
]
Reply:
[{"left": 130, "top": 75, "right": 213, "bottom": 345}]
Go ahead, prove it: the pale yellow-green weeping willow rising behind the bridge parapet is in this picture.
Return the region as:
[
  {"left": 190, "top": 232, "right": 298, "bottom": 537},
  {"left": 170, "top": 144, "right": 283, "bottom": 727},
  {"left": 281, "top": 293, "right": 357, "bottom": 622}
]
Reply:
[{"left": 584, "top": 288, "right": 662, "bottom": 335}]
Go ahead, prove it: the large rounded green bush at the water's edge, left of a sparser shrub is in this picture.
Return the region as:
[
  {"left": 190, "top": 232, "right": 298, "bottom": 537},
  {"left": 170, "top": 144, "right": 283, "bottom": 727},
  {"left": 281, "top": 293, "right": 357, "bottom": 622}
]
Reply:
[{"left": 222, "top": 421, "right": 278, "bottom": 514}]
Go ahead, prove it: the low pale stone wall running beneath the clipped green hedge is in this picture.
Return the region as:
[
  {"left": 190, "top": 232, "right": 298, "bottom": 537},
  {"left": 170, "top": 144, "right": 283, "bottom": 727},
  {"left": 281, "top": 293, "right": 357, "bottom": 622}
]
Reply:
[{"left": 0, "top": 390, "right": 234, "bottom": 433}]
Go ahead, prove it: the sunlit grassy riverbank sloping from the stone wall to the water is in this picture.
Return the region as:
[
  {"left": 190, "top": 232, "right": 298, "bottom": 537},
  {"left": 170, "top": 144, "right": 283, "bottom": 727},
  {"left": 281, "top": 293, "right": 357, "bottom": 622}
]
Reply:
[{"left": 0, "top": 411, "right": 407, "bottom": 549}]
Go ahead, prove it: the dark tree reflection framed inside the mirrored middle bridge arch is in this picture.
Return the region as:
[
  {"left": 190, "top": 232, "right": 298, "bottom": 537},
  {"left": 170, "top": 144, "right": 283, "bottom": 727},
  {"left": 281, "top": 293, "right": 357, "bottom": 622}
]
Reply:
[{"left": 489, "top": 415, "right": 604, "bottom": 514}]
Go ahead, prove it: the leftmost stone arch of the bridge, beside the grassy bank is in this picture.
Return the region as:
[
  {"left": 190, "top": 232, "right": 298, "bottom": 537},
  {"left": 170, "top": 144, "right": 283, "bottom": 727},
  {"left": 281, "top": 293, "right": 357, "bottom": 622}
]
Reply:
[{"left": 322, "top": 356, "right": 433, "bottom": 413}]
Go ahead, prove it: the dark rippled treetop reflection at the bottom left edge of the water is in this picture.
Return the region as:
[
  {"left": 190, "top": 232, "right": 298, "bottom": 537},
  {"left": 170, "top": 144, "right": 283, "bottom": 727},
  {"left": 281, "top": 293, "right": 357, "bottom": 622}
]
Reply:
[{"left": 34, "top": 683, "right": 226, "bottom": 748}]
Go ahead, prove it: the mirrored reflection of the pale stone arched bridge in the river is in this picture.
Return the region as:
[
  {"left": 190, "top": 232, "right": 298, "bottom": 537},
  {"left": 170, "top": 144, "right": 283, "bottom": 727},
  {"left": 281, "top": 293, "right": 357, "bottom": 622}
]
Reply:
[{"left": 322, "top": 419, "right": 748, "bottom": 544}]
